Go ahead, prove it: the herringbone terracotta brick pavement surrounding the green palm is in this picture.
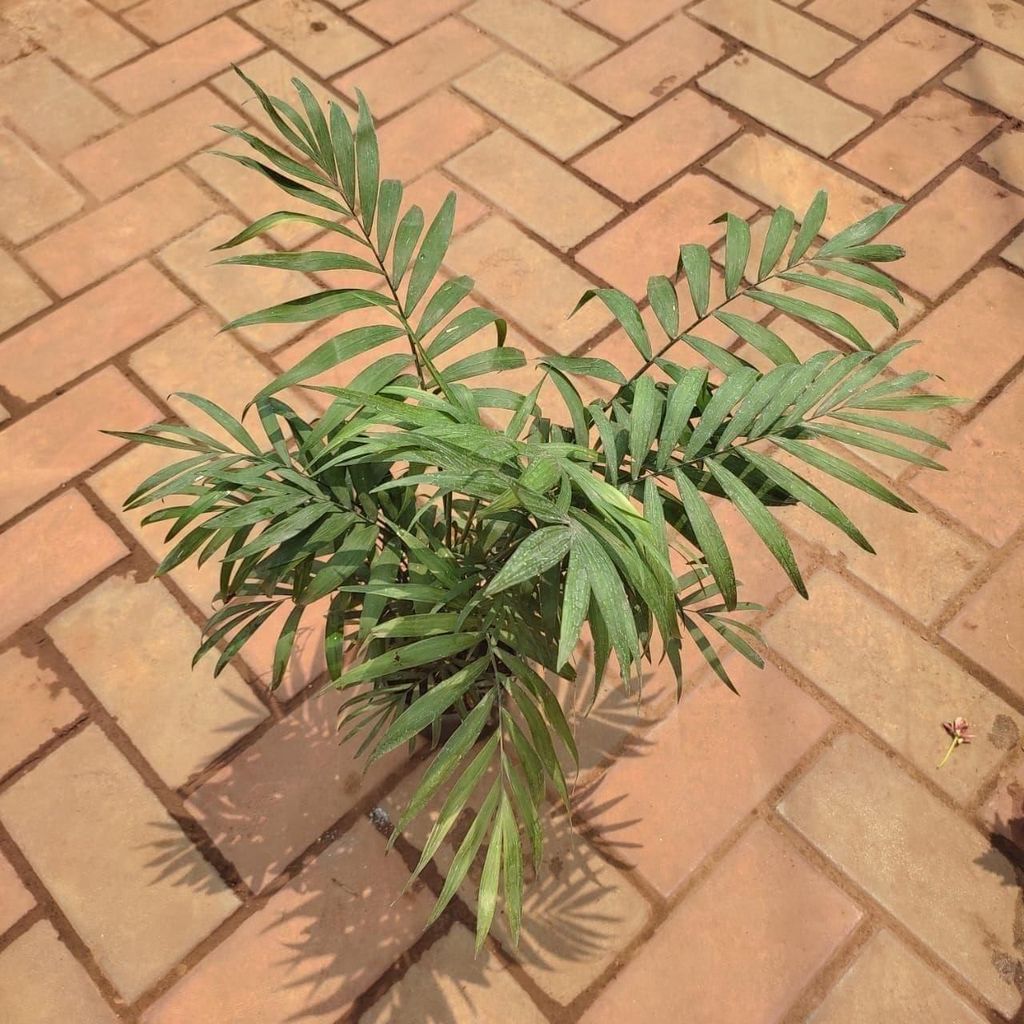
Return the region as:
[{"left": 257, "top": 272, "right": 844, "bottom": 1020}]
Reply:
[{"left": 0, "top": 0, "right": 1024, "bottom": 1024}]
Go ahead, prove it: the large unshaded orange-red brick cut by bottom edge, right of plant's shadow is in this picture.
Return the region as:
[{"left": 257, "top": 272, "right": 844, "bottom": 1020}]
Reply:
[{"left": 581, "top": 822, "right": 860, "bottom": 1024}]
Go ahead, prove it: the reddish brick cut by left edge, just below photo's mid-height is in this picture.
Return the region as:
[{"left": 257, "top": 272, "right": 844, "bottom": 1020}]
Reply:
[{"left": 0, "top": 489, "right": 128, "bottom": 639}]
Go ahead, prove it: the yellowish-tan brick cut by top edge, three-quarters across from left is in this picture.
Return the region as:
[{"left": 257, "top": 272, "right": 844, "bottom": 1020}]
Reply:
[{"left": 689, "top": 0, "right": 852, "bottom": 75}]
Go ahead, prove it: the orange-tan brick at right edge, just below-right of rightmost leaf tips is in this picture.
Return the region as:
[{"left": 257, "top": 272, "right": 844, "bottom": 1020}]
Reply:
[{"left": 912, "top": 377, "right": 1024, "bottom": 545}]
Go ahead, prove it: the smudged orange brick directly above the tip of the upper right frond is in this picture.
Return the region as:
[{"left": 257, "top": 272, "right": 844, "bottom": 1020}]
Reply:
[{"left": 839, "top": 89, "right": 999, "bottom": 199}]
